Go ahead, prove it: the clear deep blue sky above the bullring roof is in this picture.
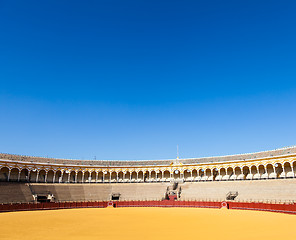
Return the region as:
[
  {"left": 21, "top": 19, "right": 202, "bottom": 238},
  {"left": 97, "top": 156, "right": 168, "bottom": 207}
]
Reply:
[{"left": 0, "top": 0, "right": 296, "bottom": 159}]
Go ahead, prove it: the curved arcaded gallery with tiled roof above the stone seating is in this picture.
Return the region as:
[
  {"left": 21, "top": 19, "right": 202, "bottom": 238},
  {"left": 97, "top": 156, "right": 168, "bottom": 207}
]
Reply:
[{"left": 0, "top": 147, "right": 296, "bottom": 183}]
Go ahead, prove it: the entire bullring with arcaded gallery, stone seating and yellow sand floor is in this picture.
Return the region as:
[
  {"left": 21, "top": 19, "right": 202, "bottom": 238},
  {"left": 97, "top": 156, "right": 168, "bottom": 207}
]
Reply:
[{"left": 0, "top": 147, "right": 296, "bottom": 239}]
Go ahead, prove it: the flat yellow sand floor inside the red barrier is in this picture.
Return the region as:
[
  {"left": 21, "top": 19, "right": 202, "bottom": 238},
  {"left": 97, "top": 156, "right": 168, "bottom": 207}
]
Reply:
[{"left": 0, "top": 208, "right": 296, "bottom": 240}]
